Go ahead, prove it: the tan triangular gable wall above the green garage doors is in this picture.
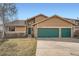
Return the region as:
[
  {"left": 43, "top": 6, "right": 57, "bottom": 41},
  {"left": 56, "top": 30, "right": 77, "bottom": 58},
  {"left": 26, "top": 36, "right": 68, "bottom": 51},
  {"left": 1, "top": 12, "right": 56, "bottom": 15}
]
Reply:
[{"left": 37, "top": 17, "right": 73, "bottom": 27}]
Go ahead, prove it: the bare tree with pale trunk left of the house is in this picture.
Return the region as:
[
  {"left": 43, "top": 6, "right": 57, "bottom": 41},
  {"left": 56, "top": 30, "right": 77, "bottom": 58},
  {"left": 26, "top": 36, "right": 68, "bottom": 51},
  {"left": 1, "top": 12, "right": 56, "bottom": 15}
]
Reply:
[{"left": 0, "top": 3, "right": 17, "bottom": 39}]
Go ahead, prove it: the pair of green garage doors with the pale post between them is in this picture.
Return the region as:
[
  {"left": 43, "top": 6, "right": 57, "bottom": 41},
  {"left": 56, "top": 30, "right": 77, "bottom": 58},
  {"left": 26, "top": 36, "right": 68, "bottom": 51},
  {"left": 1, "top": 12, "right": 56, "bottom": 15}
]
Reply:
[{"left": 37, "top": 28, "right": 71, "bottom": 38}]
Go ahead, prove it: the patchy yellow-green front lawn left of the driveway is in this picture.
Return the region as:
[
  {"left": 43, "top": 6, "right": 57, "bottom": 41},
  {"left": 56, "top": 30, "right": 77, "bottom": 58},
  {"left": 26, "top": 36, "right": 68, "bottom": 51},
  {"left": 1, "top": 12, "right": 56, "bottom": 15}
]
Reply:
[{"left": 0, "top": 38, "right": 36, "bottom": 56}]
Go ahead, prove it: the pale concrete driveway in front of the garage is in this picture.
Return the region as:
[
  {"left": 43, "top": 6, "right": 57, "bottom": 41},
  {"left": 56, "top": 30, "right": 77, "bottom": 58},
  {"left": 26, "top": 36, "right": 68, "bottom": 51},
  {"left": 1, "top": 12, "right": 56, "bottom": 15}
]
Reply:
[{"left": 36, "top": 39, "right": 79, "bottom": 56}]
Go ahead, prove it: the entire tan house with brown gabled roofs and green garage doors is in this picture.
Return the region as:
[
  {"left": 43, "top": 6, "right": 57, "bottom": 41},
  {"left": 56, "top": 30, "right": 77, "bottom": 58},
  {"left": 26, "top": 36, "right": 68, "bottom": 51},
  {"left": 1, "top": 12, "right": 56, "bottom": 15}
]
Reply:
[{"left": 6, "top": 14, "right": 76, "bottom": 38}]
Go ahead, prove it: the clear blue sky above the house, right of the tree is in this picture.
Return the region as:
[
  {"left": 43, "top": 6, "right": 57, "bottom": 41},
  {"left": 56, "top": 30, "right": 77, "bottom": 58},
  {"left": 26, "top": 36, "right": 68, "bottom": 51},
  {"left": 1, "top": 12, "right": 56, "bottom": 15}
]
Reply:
[{"left": 16, "top": 3, "right": 79, "bottom": 19}]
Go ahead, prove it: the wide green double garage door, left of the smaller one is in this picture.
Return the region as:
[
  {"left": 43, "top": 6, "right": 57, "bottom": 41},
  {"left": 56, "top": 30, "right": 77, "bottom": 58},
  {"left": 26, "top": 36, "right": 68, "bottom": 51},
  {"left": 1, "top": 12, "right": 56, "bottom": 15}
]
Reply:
[{"left": 38, "top": 28, "right": 59, "bottom": 38}]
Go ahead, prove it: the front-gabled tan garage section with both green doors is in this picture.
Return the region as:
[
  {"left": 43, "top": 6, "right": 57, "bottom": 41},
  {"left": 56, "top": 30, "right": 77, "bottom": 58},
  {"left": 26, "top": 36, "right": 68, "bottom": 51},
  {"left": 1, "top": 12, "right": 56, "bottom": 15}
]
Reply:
[{"left": 33, "top": 15, "right": 75, "bottom": 38}]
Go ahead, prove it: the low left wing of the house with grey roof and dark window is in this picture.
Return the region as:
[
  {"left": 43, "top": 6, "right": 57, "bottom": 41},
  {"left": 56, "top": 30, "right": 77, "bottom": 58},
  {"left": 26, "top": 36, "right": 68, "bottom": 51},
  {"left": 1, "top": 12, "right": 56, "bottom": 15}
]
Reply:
[{"left": 6, "top": 20, "right": 27, "bottom": 33}]
